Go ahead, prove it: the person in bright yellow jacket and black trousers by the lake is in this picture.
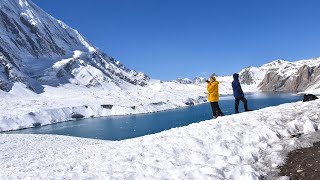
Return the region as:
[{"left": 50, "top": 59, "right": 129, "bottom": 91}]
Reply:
[{"left": 207, "top": 75, "right": 223, "bottom": 118}]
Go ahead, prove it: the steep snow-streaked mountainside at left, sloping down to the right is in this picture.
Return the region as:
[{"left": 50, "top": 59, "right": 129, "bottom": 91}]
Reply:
[{"left": 0, "top": 0, "right": 149, "bottom": 91}]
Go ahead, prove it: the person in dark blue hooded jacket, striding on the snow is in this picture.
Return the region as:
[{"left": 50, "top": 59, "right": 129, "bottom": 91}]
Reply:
[{"left": 232, "top": 73, "right": 251, "bottom": 113}]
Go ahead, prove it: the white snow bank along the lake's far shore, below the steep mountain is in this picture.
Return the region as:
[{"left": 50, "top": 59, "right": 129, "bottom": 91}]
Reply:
[{"left": 0, "top": 78, "right": 256, "bottom": 132}]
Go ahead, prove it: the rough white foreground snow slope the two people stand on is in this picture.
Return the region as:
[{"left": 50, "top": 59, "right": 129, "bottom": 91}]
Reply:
[{"left": 0, "top": 100, "right": 320, "bottom": 179}]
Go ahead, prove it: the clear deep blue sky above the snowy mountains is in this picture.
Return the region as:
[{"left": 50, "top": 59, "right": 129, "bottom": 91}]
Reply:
[{"left": 33, "top": 0, "right": 320, "bottom": 80}]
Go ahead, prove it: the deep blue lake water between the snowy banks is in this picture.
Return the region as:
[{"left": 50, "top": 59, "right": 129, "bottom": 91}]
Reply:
[{"left": 10, "top": 93, "right": 302, "bottom": 141}]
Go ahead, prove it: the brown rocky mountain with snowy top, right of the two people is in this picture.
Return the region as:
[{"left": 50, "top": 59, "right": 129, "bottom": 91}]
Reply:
[{"left": 240, "top": 58, "right": 320, "bottom": 91}]
